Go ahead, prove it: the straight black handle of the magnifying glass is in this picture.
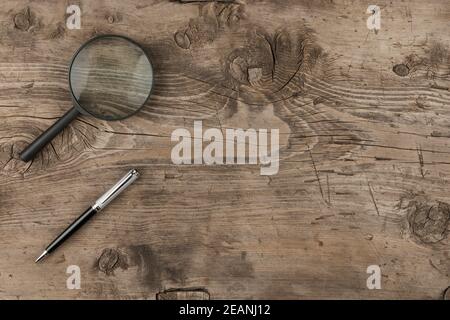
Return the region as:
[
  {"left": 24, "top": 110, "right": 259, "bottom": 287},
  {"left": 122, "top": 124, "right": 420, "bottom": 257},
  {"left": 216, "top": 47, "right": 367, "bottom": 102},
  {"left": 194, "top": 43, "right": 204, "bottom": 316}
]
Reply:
[{"left": 20, "top": 107, "right": 80, "bottom": 162}]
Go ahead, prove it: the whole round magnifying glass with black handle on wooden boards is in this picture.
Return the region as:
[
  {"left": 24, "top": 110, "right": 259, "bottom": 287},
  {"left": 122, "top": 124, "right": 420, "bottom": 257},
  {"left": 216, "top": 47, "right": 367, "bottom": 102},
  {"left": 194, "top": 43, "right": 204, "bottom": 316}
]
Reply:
[{"left": 20, "top": 35, "right": 153, "bottom": 161}]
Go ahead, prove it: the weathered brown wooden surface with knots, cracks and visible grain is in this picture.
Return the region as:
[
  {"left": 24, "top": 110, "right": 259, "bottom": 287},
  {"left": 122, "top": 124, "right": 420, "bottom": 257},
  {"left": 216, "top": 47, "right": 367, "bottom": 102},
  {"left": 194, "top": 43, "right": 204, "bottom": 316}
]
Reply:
[{"left": 0, "top": 0, "right": 450, "bottom": 299}]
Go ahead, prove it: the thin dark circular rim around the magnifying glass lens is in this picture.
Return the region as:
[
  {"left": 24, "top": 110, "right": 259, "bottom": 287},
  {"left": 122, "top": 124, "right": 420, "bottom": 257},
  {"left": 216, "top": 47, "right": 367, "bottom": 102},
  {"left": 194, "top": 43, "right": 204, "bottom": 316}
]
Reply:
[{"left": 67, "top": 34, "right": 155, "bottom": 121}]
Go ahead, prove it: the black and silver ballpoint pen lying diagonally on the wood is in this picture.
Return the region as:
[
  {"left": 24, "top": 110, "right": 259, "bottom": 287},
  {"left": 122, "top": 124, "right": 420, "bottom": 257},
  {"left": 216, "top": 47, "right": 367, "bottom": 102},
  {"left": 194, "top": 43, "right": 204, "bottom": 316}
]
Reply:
[{"left": 35, "top": 169, "right": 139, "bottom": 262}]
